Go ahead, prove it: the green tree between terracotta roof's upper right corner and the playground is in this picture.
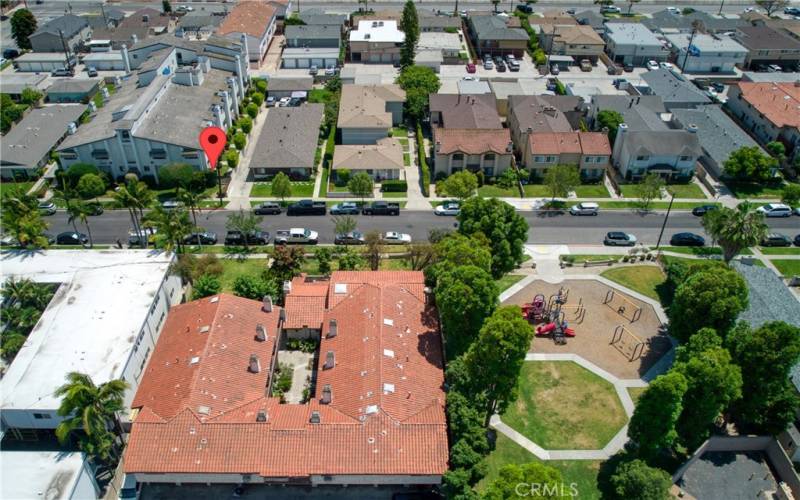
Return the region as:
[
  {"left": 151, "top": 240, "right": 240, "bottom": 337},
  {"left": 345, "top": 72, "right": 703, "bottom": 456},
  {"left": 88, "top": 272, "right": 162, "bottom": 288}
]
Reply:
[{"left": 435, "top": 266, "right": 499, "bottom": 357}]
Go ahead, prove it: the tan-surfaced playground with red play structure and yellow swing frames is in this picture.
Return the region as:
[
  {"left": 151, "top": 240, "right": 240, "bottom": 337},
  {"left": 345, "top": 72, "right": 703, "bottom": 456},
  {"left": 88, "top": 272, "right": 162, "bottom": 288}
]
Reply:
[{"left": 504, "top": 280, "right": 671, "bottom": 379}]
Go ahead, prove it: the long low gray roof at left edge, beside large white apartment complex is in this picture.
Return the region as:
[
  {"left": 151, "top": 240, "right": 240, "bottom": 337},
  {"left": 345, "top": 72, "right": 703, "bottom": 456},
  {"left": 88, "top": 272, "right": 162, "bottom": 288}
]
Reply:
[{"left": 0, "top": 104, "right": 86, "bottom": 179}]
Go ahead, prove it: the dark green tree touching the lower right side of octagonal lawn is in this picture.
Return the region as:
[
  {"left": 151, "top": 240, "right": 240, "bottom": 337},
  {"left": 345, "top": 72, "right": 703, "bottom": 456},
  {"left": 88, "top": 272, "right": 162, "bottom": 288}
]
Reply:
[{"left": 628, "top": 371, "right": 688, "bottom": 460}]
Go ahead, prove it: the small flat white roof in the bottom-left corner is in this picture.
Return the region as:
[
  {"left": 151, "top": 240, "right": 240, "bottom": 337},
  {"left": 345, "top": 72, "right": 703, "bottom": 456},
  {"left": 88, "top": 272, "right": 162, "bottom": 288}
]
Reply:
[{"left": 0, "top": 451, "right": 84, "bottom": 500}]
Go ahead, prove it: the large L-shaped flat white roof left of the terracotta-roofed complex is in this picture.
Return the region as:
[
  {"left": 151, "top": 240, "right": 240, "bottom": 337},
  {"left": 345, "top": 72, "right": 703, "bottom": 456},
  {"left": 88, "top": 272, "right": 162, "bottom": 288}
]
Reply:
[{"left": 0, "top": 250, "right": 173, "bottom": 410}]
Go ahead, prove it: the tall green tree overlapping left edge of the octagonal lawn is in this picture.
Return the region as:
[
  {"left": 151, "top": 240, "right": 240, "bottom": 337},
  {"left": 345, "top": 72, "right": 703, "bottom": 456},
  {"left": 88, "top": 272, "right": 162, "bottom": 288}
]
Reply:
[{"left": 464, "top": 306, "right": 533, "bottom": 425}]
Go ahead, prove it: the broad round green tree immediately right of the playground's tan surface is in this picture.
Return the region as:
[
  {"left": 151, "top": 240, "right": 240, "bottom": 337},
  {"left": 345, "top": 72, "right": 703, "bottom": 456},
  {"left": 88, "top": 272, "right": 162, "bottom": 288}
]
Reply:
[{"left": 669, "top": 268, "right": 748, "bottom": 342}]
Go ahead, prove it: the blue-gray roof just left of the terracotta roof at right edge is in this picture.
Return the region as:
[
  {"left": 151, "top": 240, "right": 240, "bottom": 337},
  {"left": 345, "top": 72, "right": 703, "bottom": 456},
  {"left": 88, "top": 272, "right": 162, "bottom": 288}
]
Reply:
[{"left": 672, "top": 106, "right": 766, "bottom": 177}]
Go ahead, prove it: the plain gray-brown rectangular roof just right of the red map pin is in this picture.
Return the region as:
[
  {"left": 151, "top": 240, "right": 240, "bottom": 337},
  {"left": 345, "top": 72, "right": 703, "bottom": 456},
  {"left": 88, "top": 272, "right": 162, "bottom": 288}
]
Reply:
[{"left": 250, "top": 103, "right": 325, "bottom": 179}]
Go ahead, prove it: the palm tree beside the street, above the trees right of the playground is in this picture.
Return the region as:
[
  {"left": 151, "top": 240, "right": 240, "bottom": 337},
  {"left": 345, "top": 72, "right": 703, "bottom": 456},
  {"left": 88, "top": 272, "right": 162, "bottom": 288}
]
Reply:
[{"left": 703, "top": 201, "right": 769, "bottom": 262}]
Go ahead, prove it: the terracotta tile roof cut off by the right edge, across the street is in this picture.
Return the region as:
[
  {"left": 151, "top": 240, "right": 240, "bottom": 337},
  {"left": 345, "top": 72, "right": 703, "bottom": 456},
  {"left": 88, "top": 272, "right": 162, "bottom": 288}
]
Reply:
[{"left": 738, "top": 82, "right": 800, "bottom": 128}]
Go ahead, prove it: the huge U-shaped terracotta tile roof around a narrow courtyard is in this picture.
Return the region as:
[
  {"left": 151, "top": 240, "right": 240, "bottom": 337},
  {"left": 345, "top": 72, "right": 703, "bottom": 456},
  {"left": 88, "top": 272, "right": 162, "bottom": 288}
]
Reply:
[{"left": 125, "top": 271, "right": 448, "bottom": 478}]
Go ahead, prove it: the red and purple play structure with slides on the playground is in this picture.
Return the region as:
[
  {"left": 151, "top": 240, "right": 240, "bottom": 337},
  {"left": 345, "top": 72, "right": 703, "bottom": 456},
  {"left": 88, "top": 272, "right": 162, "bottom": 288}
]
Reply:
[{"left": 522, "top": 288, "right": 586, "bottom": 344}]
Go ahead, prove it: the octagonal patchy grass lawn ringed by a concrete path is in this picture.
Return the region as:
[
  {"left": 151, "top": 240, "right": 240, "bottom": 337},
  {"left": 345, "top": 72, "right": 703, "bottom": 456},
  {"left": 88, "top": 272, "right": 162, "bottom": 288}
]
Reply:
[{"left": 502, "top": 361, "right": 627, "bottom": 450}]
